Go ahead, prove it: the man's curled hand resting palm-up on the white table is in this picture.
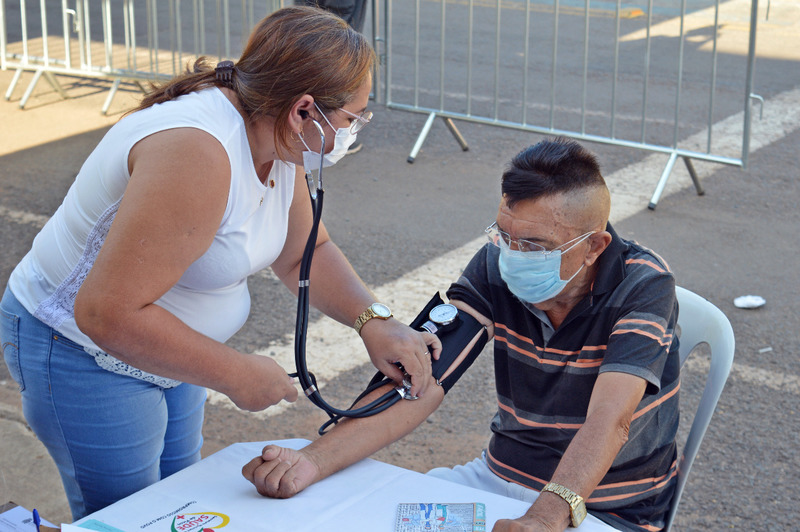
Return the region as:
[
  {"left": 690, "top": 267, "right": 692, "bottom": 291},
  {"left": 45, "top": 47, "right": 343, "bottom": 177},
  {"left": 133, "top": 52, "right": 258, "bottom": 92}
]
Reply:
[{"left": 242, "top": 445, "right": 319, "bottom": 499}]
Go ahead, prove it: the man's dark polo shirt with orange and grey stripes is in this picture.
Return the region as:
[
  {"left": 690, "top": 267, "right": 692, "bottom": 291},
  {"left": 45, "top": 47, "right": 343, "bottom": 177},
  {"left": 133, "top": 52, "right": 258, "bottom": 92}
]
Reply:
[{"left": 447, "top": 224, "right": 680, "bottom": 530}]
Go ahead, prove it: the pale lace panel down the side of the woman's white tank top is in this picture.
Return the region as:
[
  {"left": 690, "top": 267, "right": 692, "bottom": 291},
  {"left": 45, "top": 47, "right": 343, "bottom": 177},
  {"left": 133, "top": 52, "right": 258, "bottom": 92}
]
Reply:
[{"left": 33, "top": 198, "right": 122, "bottom": 330}]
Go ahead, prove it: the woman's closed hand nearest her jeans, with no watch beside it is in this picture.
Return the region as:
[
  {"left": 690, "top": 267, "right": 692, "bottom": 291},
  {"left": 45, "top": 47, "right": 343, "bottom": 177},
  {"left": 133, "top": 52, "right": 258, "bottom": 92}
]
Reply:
[{"left": 220, "top": 355, "right": 297, "bottom": 412}]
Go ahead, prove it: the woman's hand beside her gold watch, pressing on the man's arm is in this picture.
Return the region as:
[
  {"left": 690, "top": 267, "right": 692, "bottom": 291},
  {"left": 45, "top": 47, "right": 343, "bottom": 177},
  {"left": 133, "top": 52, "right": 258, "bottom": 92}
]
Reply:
[{"left": 361, "top": 318, "right": 442, "bottom": 397}]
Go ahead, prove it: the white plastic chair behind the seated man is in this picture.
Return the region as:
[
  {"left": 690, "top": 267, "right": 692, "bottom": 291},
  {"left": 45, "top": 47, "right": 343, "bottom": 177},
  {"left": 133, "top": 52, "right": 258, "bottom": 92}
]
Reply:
[{"left": 664, "top": 287, "right": 735, "bottom": 531}]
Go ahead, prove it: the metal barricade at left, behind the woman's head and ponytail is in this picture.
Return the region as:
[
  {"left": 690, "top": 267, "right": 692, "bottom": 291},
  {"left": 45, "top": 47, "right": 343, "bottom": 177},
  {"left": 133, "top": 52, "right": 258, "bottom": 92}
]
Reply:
[{"left": 0, "top": 0, "right": 286, "bottom": 113}]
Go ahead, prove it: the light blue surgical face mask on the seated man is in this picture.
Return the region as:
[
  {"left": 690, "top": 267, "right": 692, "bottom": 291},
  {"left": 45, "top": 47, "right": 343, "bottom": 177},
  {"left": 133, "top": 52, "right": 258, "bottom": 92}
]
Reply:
[{"left": 497, "top": 233, "right": 591, "bottom": 304}]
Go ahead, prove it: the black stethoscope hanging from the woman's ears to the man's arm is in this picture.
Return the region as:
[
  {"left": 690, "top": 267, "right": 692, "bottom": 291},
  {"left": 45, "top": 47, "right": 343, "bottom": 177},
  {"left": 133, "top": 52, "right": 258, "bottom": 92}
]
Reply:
[{"left": 289, "top": 118, "right": 415, "bottom": 435}]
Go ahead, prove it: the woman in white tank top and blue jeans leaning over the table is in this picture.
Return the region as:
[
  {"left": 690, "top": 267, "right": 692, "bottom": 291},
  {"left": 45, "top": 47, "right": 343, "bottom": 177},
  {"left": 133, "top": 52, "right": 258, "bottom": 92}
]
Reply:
[{"left": 0, "top": 7, "right": 440, "bottom": 520}]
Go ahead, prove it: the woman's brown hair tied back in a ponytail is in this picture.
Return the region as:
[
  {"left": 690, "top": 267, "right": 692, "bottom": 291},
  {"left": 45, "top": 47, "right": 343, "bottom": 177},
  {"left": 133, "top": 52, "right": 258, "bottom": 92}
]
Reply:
[{"left": 134, "top": 6, "right": 375, "bottom": 154}]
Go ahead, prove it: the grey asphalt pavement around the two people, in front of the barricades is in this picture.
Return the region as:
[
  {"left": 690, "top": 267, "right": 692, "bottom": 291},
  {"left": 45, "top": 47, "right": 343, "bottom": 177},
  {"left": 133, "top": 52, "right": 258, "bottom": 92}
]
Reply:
[{"left": 0, "top": 1, "right": 800, "bottom": 530}]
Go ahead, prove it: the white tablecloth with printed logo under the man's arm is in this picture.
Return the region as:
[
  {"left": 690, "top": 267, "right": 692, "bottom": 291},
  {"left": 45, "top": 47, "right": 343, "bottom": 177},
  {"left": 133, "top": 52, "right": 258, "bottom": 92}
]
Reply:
[{"left": 75, "top": 440, "right": 608, "bottom": 532}]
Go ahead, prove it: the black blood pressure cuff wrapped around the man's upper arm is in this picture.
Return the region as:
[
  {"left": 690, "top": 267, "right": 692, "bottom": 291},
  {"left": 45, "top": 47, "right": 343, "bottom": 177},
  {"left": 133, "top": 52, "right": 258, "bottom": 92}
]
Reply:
[{"left": 370, "top": 292, "right": 489, "bottom": 394}]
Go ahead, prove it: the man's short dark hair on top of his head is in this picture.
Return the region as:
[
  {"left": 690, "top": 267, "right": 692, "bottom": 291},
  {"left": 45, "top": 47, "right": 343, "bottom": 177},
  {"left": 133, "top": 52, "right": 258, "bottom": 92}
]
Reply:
[{"left": 501, "top": 137, "right": 606, "bottom": 207}]
